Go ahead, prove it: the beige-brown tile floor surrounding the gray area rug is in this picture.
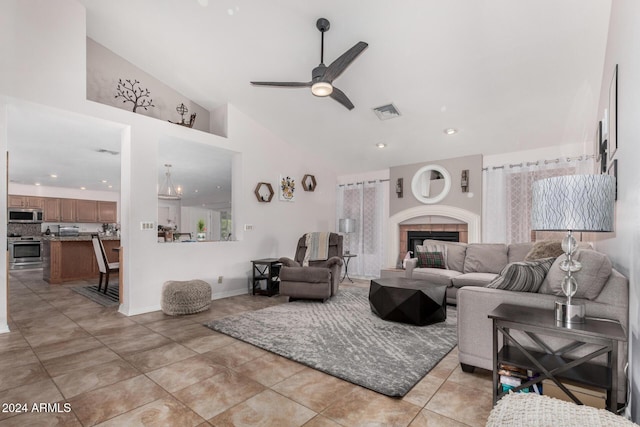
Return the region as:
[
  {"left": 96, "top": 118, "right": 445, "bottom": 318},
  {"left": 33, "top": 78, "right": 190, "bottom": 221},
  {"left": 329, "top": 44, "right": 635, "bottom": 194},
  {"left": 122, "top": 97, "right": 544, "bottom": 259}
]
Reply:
[{"left": 0, "top": 270, "right": 491, "bottom": 427}]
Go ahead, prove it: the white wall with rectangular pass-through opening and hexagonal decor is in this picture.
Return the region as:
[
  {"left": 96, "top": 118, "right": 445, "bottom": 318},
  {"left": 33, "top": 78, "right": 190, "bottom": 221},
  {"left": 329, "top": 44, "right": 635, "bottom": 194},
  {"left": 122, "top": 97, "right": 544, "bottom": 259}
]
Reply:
[{"left": 0, "top": 0, "right": 336, "bottom": 330}]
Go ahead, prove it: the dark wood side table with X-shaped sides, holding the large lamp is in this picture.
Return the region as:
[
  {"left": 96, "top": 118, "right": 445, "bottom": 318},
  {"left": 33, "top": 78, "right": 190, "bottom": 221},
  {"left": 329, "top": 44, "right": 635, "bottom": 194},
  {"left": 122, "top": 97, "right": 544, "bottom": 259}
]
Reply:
[{"left": 489, "top": 304, "right": 627, "bottom": 412}]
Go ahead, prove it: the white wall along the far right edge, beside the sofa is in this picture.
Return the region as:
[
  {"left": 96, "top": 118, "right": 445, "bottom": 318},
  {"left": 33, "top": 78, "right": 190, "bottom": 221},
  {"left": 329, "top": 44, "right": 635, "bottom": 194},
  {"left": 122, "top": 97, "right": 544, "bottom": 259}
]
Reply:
[{"left": 597, "top": 0, "right": 640, "bottom": 422}]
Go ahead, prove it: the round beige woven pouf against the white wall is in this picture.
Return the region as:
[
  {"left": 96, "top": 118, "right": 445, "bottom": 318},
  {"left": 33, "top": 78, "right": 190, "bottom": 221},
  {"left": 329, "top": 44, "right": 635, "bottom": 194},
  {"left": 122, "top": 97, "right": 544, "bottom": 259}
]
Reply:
[{"left": 160, "top": 280, "right": 211, "bottom": 316}]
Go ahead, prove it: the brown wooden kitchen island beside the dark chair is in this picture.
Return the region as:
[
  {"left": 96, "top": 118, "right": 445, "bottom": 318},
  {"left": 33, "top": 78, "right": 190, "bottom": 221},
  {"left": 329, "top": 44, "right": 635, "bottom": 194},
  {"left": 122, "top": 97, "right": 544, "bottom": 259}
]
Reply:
[{"left": 42, "top": 234, "right": 120, "bottom": 284}]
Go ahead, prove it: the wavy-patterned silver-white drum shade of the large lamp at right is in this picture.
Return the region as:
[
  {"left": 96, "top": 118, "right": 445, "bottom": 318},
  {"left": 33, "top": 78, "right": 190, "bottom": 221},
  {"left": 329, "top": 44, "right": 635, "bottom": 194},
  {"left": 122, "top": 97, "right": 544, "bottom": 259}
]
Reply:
[{"left": 531, "top": 175, "right": 616, "bottom": 231}]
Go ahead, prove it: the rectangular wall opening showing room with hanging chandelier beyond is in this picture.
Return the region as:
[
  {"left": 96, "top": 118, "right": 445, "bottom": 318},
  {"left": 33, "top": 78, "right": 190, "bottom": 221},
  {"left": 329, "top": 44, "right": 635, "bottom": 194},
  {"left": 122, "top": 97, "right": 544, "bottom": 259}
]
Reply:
[{"left": 157, "top": 137, "right": 235, "bottom": 242}]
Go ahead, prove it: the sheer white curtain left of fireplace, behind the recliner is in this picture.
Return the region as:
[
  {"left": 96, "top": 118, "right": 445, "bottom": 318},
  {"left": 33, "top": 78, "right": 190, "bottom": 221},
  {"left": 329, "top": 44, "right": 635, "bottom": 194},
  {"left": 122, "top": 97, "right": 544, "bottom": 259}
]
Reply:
[{"left": 336, "top": 181, "right": 389, "bottom": 278}]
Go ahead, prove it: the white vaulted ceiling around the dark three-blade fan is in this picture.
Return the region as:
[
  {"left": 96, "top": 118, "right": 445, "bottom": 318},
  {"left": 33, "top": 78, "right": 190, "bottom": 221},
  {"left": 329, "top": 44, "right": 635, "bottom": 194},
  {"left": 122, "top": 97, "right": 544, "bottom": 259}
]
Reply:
[{"left": 80, "top": 0, "right": 611, "bottom": 174}]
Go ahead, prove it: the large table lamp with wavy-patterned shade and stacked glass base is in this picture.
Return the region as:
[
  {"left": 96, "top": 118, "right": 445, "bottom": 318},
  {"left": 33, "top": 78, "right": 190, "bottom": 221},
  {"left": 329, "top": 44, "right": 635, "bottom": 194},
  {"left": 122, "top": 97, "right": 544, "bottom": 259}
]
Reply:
[{"left": 531, "top": 175, "right": 615, "bottom": 324}]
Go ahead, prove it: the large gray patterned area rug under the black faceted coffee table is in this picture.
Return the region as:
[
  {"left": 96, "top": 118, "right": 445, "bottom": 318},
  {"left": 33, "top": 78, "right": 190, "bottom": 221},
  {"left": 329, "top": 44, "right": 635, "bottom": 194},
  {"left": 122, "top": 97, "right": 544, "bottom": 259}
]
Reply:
[{"left": 206, "top": 288, "right": 457, "bottom": 397}]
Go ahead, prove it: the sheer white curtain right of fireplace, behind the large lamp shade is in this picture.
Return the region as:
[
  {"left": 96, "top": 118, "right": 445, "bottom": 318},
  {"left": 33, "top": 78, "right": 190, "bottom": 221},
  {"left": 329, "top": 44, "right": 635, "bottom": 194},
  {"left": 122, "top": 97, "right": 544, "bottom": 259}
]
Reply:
[{"left": 482, "top": 156, "right": 593, "bottom": 243}]
